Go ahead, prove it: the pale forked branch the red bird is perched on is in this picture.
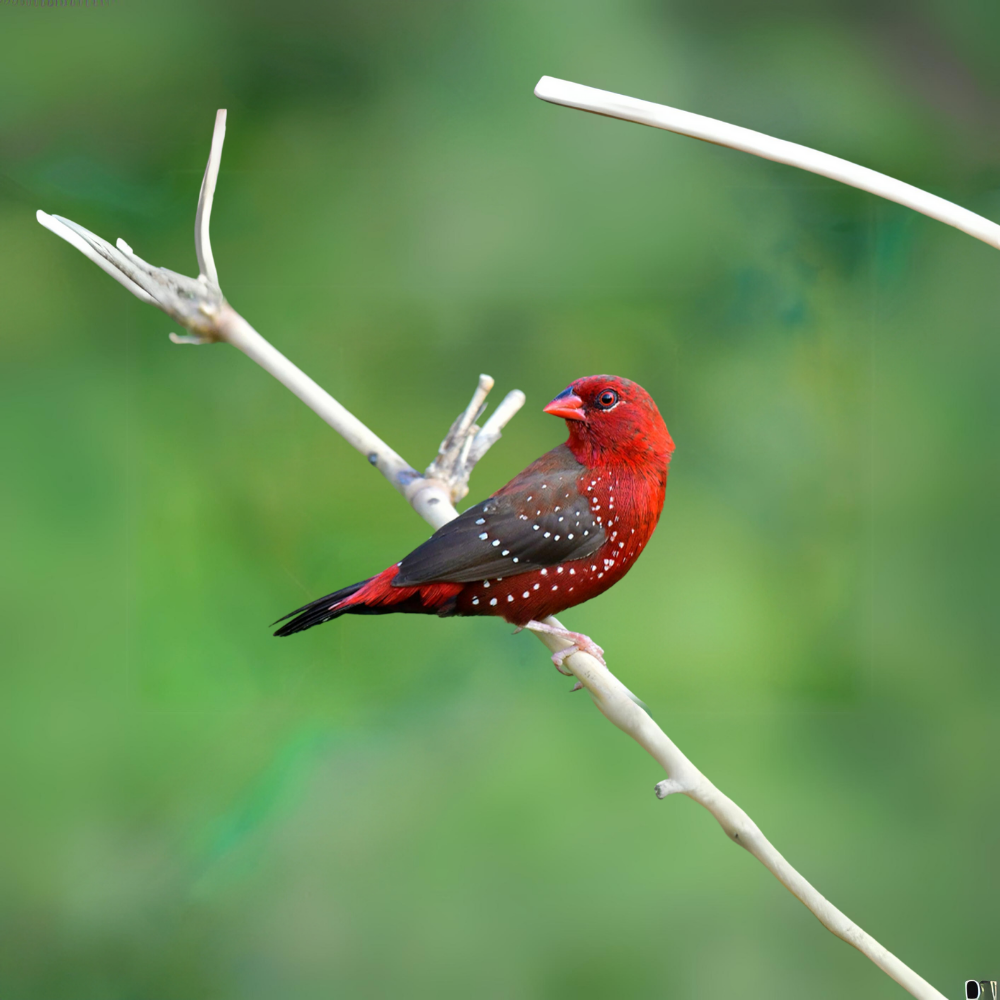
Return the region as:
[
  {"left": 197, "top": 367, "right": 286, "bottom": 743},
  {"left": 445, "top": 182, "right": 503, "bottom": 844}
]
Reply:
[{"left": 38, "top": 111, "right": 945, "bottom": 1000}]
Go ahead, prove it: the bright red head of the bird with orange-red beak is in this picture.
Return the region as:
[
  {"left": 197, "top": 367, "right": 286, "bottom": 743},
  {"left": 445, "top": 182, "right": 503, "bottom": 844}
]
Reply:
[{"left": 545, "top": 375, "right": 674, "bottom": 465}]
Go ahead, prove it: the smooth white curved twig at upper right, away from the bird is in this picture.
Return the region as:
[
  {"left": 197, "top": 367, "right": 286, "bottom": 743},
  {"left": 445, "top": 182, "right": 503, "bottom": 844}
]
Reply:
[{"left": 535, "top": 76, "right": 1000, "bottom": 248}]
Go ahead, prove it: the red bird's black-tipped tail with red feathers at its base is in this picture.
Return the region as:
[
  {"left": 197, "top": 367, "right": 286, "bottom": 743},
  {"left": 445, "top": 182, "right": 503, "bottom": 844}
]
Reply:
[{"left": 274, "top": 565, "right": 462, "bottom": 636}]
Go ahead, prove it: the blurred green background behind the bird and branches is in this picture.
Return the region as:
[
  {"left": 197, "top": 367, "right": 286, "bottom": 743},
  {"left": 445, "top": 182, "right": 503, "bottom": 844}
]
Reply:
[{"left": 0, "top": 0, "right": 1000, "bottom": 1000}]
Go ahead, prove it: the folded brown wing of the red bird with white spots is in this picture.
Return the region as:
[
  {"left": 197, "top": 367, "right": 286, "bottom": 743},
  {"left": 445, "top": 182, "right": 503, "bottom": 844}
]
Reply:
[{"left": 392, "top": 452, "right": 605, "bottom": 587}]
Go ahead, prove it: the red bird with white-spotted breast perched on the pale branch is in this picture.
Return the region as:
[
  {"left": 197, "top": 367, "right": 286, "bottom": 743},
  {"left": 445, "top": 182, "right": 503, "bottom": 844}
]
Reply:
[{"left": 274, "top": 375, "right": 674, "bottom": 670}]
